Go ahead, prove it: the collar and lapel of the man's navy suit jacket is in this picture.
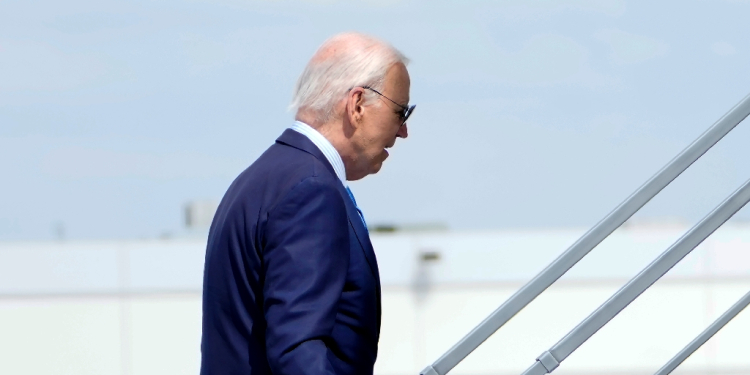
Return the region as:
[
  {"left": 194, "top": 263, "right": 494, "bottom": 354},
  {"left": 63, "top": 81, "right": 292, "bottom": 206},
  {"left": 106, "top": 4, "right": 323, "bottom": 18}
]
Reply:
[{"left": 276, "top": 129, "right": 380, "bottom": 284}]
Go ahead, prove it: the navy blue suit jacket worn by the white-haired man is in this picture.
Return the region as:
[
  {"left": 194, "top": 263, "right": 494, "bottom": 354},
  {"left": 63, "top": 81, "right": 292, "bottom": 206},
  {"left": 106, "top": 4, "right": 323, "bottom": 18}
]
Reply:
[{"left": 201, "top": 129, "right": 380, "bottom": 375}]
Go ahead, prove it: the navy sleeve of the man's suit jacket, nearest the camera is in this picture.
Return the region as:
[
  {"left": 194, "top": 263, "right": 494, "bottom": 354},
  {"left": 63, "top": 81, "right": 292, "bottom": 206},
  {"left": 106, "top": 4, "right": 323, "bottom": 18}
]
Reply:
[{"left": 263, "top": 177, "right": 349, "bottom": 375}]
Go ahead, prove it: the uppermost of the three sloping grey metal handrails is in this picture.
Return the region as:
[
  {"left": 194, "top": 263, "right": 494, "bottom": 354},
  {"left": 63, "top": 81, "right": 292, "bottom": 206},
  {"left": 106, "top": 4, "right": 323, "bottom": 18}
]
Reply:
[{"left": 420, "top": 95, "right": 750, "bottom": 375}]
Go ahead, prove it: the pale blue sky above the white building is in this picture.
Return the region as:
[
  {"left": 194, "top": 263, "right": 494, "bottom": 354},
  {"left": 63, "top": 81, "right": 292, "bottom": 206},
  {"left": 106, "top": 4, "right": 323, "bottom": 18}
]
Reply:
[{"left": 0, "top": 0, "right": 750, "bottom": 240}]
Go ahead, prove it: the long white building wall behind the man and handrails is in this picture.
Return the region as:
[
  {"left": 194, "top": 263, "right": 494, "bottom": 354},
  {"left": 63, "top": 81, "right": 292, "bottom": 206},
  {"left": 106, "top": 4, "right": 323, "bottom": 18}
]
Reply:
[{"left": 0, "top": 223, "right": 750, "bottom": 375}]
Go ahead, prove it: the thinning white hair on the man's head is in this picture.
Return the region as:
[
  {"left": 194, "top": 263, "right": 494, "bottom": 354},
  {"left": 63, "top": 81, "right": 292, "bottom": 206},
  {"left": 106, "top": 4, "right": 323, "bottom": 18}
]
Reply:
[{"left": 289, "top": 33, "right": 409, "bottom": 124}]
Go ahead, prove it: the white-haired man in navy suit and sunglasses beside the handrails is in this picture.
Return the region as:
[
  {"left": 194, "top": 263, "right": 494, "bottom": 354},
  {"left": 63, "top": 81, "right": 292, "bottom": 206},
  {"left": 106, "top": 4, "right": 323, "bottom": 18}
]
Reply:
[{"left": 201, "top": 33, "right": 414, "bottom": 375}]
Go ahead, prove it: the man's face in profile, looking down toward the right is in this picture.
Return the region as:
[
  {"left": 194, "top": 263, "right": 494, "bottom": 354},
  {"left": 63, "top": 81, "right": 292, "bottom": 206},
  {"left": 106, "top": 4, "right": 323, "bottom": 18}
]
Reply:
[{"left": 354, "top": 63, "right": 410, "bottom": 179}]
